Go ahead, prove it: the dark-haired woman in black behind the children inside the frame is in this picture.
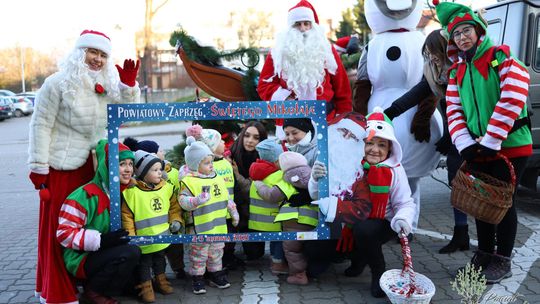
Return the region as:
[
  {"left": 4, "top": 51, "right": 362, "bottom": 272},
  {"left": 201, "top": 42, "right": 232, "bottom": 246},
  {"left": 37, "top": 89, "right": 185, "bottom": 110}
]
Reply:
[{"left": 225, "top": 121, "right": 268, "bottom": 260}]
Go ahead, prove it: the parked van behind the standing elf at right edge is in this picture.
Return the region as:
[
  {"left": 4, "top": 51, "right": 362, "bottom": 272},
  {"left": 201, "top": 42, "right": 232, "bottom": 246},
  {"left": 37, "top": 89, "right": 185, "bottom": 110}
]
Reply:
[{"left": 484, "top": 0, "right": 540, "bottom": 191}]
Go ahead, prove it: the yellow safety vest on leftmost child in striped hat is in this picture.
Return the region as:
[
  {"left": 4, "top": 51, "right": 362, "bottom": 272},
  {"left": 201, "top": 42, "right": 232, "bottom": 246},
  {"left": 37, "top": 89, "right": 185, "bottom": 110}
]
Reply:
[{"left": 122, "top": 183, "right": 174, "bottom": 254}]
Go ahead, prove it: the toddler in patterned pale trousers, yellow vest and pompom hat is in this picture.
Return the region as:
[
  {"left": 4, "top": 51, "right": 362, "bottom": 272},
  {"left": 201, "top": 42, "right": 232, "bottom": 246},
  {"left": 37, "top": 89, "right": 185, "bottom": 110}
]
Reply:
[{"left": 180, "top": 136, "right": 239, "bottom": 294}]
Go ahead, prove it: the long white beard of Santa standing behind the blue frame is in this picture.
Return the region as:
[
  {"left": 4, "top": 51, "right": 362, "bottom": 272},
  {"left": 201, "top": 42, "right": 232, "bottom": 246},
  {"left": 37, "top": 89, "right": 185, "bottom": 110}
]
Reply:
[{"left": 272, "top": 24, "right": 337, "bottom": 100}]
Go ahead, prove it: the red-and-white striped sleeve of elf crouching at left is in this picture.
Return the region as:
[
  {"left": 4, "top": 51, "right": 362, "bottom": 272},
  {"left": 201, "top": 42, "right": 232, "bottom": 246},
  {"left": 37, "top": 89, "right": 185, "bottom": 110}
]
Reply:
[{"left": 56, "top": 200, "right": 101, "bottom": 251}]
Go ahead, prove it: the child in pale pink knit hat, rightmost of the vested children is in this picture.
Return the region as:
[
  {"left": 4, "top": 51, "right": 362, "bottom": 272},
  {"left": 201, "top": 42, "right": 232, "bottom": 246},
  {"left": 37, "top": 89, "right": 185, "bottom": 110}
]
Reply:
[{"left": 255, "top": 151, "right": 319, "bottom": 285}]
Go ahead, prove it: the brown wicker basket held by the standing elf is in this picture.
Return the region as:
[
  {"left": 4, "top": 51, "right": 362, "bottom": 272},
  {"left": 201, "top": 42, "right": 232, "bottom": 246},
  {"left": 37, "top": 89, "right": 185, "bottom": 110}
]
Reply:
[{"left": 451, "top": 154, "right": 516, "bottom": 224}]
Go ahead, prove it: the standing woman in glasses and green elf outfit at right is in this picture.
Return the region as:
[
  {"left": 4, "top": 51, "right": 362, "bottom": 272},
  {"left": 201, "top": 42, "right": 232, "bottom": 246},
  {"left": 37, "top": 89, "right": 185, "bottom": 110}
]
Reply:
[{"left": 436, "top": 2, "right": 532, "bottom": 284}]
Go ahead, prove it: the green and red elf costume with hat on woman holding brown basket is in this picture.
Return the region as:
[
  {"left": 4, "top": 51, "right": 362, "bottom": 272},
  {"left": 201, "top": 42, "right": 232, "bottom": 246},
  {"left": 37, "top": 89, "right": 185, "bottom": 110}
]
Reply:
[{"left": 436, "top": 2, "right": 532, "bottom": 158}]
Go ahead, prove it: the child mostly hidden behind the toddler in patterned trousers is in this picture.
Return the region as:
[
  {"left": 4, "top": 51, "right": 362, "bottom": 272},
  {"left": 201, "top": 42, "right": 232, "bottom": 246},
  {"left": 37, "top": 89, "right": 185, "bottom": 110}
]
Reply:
[{"left": 184, "top": 124, "right": 244, "bottom": 270}]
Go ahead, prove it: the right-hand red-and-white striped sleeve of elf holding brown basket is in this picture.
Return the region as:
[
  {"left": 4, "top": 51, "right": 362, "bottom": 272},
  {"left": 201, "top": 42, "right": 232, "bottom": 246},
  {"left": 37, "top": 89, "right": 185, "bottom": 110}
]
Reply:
[{"left": 480, "top": 56, "right": 529, "bottom": 150}]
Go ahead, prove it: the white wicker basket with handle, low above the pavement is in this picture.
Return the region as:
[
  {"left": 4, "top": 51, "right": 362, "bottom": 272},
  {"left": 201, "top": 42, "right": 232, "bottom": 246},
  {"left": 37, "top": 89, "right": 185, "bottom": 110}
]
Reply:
[{"left": 379, "top": 269, "right": 435, "bottom": 304}]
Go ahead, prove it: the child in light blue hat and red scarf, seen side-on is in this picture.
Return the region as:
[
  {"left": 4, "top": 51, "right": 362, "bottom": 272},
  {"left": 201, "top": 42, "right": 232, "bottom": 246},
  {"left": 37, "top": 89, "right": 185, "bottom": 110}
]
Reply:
[{"left": 248, "top": 139, "right": 296, "bottom": 275}]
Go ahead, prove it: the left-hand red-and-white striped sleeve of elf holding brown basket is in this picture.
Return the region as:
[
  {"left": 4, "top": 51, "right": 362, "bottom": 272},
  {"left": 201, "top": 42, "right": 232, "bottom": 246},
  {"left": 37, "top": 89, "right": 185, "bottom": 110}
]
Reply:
[{"left": 446, "top": 76, "right": 475, "bottom": 152}]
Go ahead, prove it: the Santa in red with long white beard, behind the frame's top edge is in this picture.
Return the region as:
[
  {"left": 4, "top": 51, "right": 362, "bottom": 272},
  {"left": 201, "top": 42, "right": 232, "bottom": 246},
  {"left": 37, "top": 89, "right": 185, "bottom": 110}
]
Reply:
[{"left": 257, "top": 0, "right": 352, "bottom": 136}]
